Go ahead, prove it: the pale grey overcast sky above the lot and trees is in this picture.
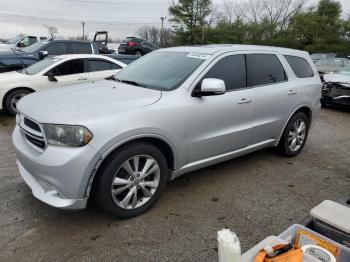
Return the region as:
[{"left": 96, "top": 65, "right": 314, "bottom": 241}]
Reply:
[{"left": 0, "top": 0, "right": 350, "bottom": 38}]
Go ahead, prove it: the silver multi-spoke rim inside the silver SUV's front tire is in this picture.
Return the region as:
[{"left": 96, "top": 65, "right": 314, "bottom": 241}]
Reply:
[{"left": 111, "top": 155, "right": 160, "bottom": 209}]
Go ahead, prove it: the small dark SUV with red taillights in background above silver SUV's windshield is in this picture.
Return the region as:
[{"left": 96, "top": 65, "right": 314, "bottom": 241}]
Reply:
[{"left": 118, "top": 37, "right": 159, "bottom": 56}]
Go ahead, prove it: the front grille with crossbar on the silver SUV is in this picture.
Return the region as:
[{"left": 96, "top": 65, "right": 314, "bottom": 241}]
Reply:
[{"left": 19, "top": 116, "right": 46, "bottom": 150}]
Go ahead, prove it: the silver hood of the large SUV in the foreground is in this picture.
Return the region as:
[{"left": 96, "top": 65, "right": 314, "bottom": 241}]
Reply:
[{"left": 17, "top": 80, "right": 162, "bottom": 124}]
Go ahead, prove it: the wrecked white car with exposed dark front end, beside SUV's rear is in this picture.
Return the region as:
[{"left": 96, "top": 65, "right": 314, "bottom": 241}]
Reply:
[{"left": 321, "top": 65, "right": 350, "bottom": 108}]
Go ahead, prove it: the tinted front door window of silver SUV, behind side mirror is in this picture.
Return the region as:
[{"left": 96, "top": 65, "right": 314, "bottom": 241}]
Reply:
[{"left": 203, "top": 55, "right": 246, "bottom": 90}]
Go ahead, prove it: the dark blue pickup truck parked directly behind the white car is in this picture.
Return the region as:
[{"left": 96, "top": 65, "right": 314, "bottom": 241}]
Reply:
[{"left": 0, "top": 34, "right": 138, "bottom": 73}]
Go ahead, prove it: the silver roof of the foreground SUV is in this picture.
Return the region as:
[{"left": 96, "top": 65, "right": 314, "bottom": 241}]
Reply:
[{"left": 160, "top": 44, "right": 307, "bottom": 55}]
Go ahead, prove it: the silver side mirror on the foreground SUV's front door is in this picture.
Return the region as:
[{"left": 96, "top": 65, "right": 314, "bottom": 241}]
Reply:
[{"left": 192, "top": 78, "right": 226, "bottom": 97}]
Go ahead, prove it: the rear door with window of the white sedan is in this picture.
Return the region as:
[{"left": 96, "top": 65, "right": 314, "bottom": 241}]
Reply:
[{"left": 88, "top": 59, "right": 122, "bottom": 80}]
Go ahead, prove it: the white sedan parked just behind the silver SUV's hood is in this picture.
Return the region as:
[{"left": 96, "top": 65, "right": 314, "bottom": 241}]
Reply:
[{"left": 0, "top": 54, "right": 127, "bottom": 115}]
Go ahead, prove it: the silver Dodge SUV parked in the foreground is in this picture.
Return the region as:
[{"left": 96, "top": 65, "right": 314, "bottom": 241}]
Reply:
[{"left": 13, "top": 45, "right": 321, "bottom": 218}]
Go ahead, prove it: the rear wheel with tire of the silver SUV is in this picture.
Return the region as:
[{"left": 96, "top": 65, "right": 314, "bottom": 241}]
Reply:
[{"left": 278, "top": 112, "right": 310, "bottom": 157}]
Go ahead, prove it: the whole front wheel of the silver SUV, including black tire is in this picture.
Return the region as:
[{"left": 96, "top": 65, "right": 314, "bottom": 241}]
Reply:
[{"left": 93, "top": 142, "right": 169, "bottom": 218}]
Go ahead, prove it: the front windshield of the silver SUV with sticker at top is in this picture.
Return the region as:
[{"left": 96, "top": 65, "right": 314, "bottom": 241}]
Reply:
[{"left": 115, "top": 52, "right": 209, "bottom": 91}]
